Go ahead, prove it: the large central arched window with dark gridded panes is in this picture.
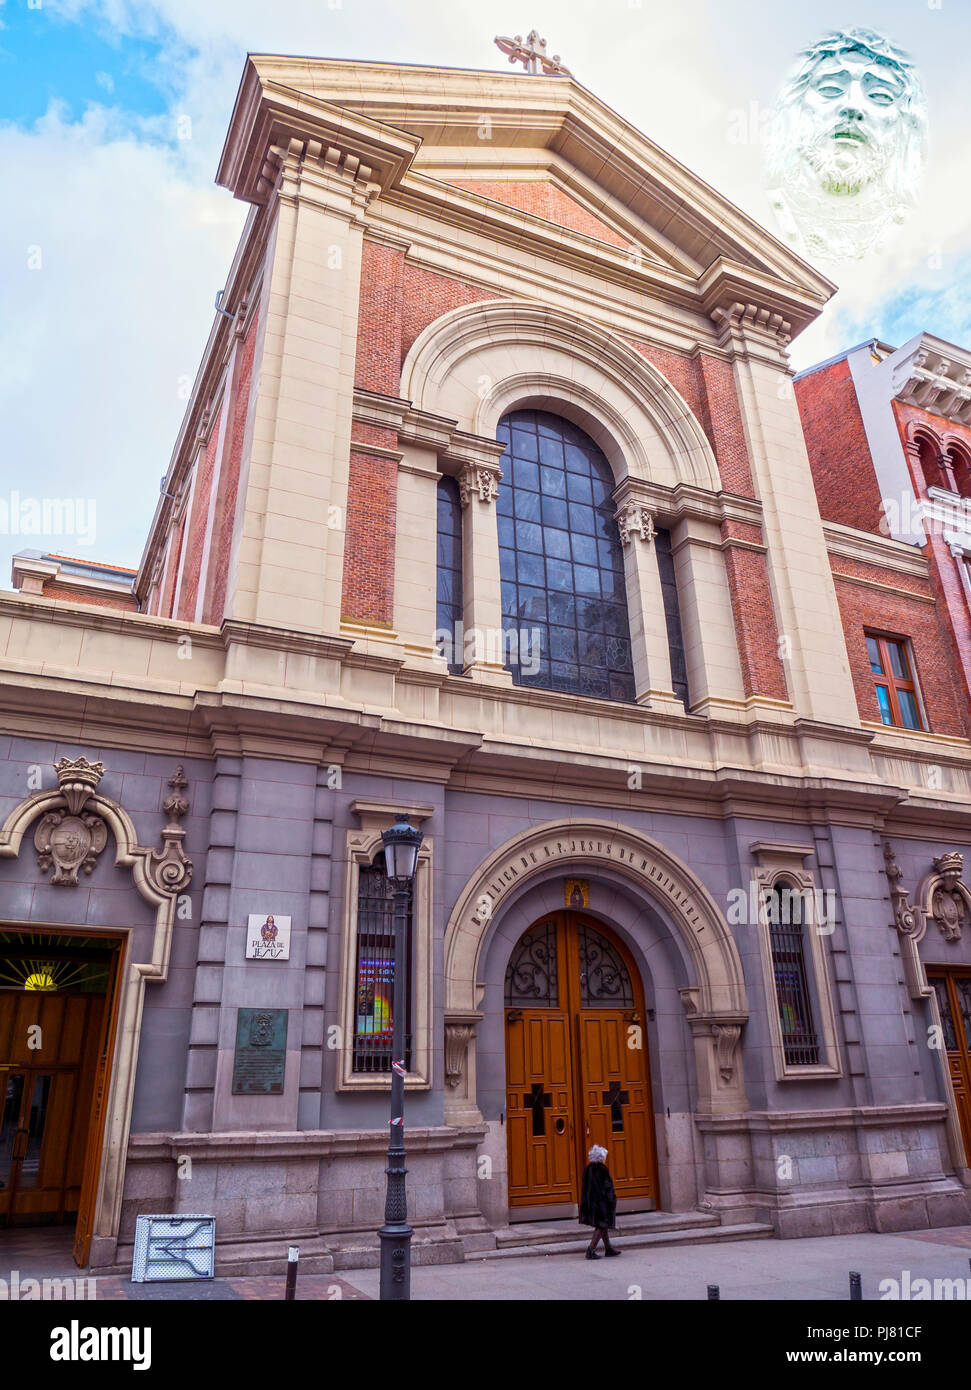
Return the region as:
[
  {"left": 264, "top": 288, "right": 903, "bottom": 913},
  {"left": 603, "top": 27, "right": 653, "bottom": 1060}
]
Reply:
[{"left": 497, "top": 410, "right": 635, "bottom": 701}]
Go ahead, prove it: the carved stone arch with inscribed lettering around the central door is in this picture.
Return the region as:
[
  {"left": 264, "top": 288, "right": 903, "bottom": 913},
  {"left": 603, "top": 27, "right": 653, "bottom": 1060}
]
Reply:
[{"left": 445, "top": 819, "right": 749, "bottom": 1123}]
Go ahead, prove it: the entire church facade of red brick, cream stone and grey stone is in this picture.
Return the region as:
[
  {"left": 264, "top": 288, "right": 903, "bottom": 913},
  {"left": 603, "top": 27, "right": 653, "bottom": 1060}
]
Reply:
[{"left": 0, "top": 57, "right": 971, "bottom": 1272}]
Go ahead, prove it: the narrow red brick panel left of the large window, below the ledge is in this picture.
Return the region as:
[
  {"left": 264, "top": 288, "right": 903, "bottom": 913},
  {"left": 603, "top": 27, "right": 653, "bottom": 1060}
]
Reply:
[{"left": 340, "top": 421, "right": 397, "bottom": 627}]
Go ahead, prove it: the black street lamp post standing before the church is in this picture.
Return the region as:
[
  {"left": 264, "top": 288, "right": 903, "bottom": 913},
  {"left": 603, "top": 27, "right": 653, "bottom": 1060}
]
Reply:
[{"left": 378, "top": 812, "right": 424, "bottom": 1300}]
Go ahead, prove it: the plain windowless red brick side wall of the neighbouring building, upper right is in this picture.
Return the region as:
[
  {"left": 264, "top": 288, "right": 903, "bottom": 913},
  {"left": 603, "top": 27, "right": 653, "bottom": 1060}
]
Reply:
[{"left": 795, "top": 359, "right": 886, "bottom": 535}]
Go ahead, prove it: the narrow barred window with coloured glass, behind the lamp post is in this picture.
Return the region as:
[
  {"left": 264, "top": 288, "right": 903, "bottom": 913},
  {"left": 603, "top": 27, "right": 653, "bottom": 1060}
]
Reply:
[{"left": 353, "top": 851, "right": 414, "bottom": 1072}]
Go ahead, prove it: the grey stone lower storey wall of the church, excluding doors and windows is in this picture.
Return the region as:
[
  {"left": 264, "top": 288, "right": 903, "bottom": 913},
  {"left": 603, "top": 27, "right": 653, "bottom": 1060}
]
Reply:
[{"left": 0, "top": 738, "right": 971, "bottom": 1270}]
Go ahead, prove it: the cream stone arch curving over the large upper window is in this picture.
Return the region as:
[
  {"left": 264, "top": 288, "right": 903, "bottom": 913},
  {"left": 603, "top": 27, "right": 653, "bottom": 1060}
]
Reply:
[{"left": 401, "top": 300, "right": 721, "bottom": 491}]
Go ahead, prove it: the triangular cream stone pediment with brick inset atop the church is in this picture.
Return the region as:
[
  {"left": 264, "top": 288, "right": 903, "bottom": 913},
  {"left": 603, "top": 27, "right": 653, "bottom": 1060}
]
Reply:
[{"left": 217, "top": 56, "right": 833, "bottom": 332}]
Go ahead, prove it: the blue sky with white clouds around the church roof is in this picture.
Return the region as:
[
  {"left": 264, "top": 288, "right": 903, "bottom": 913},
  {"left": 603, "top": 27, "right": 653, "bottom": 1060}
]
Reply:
[{"left": 0, "top": 0, "right": 971, "bottom": 585}]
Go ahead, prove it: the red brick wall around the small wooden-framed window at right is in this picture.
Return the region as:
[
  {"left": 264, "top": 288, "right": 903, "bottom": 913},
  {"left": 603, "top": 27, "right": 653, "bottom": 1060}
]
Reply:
[{"left": 831, "top": 556, "right": 971, "bottom": 738}]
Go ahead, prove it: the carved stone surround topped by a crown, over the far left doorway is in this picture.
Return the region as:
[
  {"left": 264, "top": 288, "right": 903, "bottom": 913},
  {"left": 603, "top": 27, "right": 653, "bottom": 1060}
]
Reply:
[{"left": 0, "top": 758, "right": 192, "bottom": 1265}]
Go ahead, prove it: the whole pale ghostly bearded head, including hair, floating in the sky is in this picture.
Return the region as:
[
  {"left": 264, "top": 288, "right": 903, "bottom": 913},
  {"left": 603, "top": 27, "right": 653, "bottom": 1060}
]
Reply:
[{"left": 765, "top": 29, "right": 927, "bottom": 261}]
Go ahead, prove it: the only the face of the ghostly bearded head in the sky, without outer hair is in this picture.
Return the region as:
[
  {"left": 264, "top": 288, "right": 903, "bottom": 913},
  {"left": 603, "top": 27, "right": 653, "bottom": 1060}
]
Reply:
[{"left": 797, "top": 51, "right": 904, "bottom": 196}]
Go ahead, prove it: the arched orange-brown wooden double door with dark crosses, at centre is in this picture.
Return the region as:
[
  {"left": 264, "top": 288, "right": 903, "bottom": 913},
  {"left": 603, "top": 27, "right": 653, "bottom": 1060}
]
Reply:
[{"left": 506, "top": 912, "right": 657, "bottom": 1209}]
